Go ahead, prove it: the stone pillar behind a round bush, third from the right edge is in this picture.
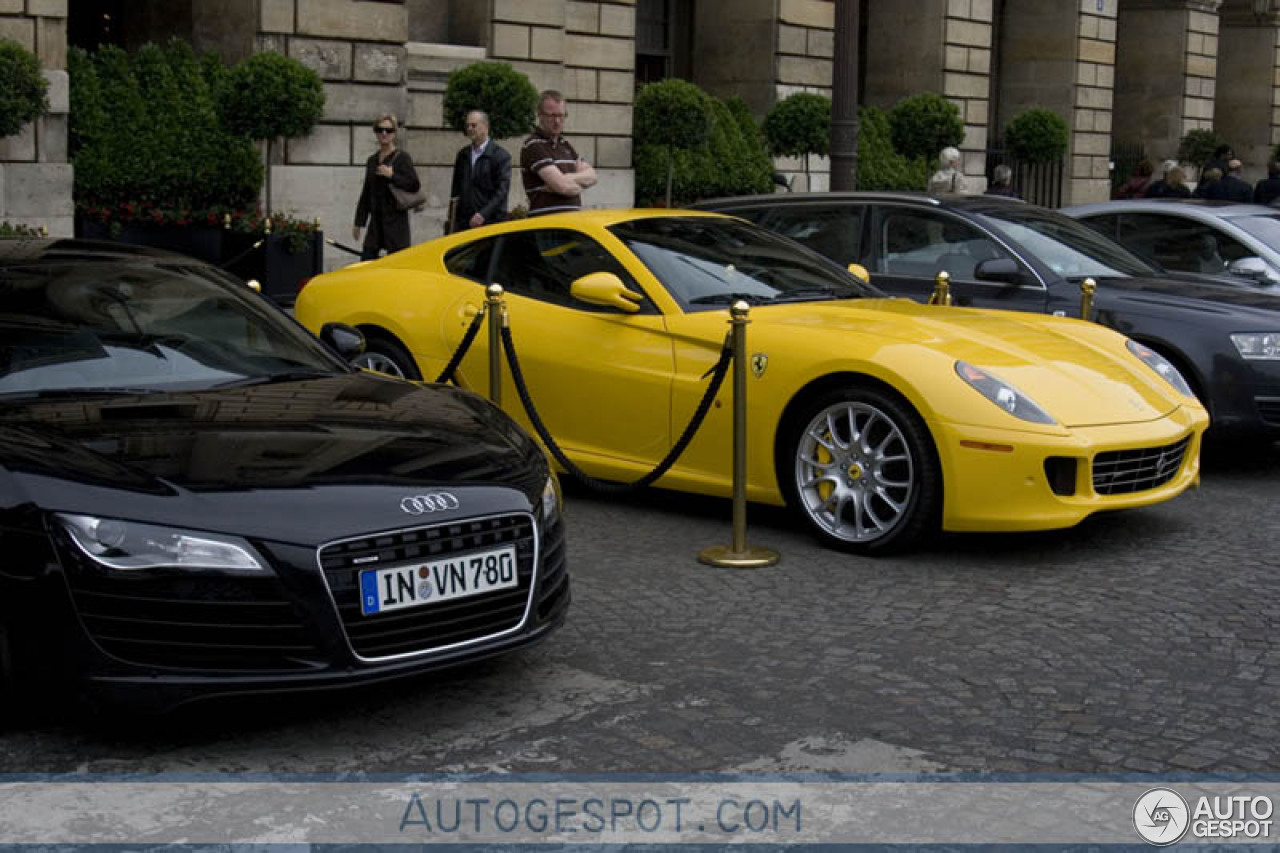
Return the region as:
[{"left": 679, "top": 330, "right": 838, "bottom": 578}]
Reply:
[{"left": 997, "top": 0, "right": 1117, "bottom": 204}]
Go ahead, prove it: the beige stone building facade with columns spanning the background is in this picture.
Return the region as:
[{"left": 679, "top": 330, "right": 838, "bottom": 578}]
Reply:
[{"left": 0, "top": 0, "right": 1280, "bottom": 264}]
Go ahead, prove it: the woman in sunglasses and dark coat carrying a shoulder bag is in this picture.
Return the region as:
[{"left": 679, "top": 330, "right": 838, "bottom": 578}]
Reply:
[{"left": 351, "top": 115, "right": 422, "bottom": 260}]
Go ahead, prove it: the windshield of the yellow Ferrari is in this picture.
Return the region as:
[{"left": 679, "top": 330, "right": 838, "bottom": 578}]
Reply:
[{"left": 609, "top": 216, "right": 882, "bottom": 311}]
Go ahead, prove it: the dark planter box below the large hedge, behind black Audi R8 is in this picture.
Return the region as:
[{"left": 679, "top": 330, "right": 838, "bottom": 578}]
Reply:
[{"left": 76, "top": 216, "right": 324, "bottom": 305}]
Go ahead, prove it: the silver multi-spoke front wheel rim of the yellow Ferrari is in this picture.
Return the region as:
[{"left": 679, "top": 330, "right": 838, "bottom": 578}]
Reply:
[{"left": 795, "top": 401, "right": 916, "bottom": 543}]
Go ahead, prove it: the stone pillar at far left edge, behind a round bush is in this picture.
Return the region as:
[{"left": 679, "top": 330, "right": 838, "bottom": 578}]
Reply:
[{"left": 0, "top": 0, "right": 74, "bottom": 237}]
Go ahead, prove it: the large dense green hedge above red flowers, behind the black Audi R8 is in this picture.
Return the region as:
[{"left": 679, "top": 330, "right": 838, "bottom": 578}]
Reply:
[{"left": 68, "top": 40, "right": 262, "bottom": 224}]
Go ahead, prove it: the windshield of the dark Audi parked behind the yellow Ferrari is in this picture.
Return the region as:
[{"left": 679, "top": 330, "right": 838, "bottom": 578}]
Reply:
[{"left": 978, "top": 205, "right": 1160, "bottom": 278}]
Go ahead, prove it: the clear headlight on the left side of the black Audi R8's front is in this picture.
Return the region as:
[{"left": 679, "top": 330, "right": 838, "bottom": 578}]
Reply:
[{"left": 56, "top": 512, "right": 265, "bottom": 571}]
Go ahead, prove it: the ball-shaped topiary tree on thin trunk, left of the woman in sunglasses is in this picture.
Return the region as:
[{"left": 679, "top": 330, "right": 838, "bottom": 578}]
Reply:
[{"left": 216, "top": 51, "right": 324, "bottom": 210}]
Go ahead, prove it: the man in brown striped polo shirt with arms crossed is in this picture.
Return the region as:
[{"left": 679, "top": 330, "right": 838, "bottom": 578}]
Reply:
[{"left": 520, "top": 90, "right": 596, "bottom": 216}]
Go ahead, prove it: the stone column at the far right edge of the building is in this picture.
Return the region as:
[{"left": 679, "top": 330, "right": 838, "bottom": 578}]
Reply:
[{"left": 1213, "top": 0, "right": 1280, "bottom": 181}]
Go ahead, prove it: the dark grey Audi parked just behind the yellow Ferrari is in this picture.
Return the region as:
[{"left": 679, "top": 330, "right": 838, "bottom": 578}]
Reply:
[{"left": 692, "top": 192, "right": 1280, "bottom": 442}]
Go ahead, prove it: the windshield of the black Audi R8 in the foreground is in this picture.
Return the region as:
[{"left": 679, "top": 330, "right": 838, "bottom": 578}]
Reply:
[{"left": 0, "top": 260, "right": 347, "bottom": 397}]
